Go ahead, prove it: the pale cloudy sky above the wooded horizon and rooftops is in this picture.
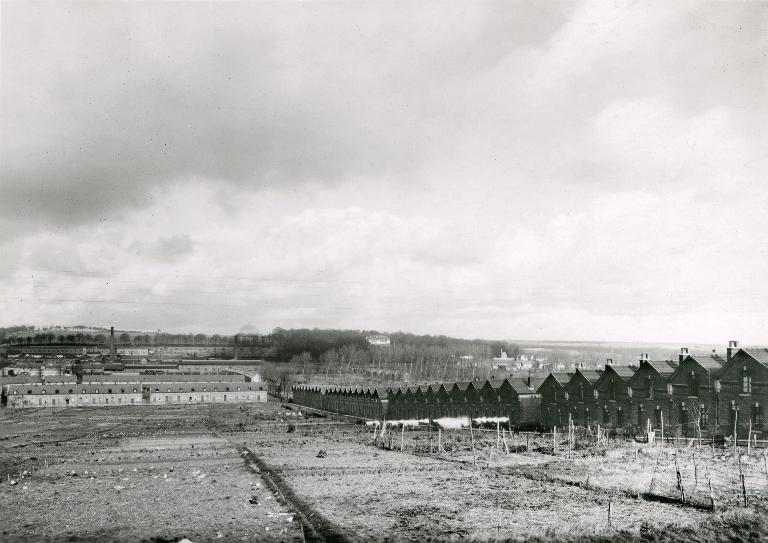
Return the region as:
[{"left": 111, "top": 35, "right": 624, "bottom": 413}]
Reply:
[{"left": 0, "top": 1, "right": 768, "bottom": 344}]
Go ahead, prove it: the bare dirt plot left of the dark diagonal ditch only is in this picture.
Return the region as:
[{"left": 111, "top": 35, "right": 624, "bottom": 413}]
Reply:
[{"left": 0, "top": 407, "right": 301, "bottom": 542}]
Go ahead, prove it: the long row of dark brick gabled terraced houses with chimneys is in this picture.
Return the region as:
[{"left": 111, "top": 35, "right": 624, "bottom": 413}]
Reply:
[{"left": 293, "top": 341, "right": 768, "bottom": 438}]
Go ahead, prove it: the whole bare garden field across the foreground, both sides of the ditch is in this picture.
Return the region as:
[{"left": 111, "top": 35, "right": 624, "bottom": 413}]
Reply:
[{"left": 0, "top": 404, "right": 768, "bottom": 542}]
